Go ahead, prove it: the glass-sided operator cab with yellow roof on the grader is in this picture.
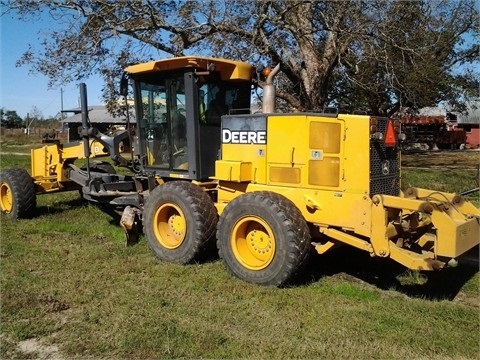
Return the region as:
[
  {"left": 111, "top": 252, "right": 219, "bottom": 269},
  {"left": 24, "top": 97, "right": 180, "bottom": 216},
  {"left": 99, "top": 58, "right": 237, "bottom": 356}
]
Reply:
[{"left": 126, "top": 58, "right": 252, "bottom": 180}]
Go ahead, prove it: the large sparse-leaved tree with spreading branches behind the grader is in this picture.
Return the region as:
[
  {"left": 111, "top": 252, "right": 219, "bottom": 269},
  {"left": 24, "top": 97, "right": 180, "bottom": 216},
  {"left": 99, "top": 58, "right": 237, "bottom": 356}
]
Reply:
[{"left": 1, "top": 0, "right": 478, "bottom": 115}]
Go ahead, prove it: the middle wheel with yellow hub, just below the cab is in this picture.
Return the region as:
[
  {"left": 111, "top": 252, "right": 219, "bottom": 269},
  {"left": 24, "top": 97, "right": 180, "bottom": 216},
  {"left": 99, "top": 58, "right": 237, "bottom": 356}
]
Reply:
[{"left": 143, "top": 181, "right": 218, "bottom": 264}]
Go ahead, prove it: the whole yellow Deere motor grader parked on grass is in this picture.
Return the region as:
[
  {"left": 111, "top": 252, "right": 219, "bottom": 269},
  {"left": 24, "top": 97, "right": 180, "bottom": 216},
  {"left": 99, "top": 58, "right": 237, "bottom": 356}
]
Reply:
[{"left": 0, "top": 57, "right": 480, "bottom": 286}]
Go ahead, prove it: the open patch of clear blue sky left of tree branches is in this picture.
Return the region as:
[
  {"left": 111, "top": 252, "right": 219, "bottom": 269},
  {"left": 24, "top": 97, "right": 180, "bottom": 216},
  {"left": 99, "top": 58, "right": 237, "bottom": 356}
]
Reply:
[{"left": 0, "top": 10, "right": 103, "bottom": 118}]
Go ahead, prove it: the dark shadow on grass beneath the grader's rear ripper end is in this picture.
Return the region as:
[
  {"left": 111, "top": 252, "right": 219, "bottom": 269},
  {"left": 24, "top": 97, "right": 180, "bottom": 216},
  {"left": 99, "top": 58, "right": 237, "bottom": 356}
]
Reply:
[{"left": 304, "top": 246, "right": 479, "bottom": 300}]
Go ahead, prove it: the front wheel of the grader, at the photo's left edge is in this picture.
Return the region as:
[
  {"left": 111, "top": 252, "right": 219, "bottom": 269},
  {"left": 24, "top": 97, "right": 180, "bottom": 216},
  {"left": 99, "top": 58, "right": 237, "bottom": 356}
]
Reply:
[{"left": 0, "top": 168, "right": 37, "bottom": 219}]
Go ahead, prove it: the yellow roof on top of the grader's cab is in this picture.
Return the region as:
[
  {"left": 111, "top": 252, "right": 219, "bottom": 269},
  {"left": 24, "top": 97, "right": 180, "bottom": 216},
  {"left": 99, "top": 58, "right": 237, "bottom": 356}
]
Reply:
[{"left": 125, "top": 56, "right": 253, "bottom": 80}]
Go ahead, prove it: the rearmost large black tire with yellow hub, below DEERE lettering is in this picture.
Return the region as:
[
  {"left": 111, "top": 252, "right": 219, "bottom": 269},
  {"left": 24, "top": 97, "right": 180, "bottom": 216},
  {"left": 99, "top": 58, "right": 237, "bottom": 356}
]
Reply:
[{"left": 217, "top": 191, "right": 311, "bottom": 287}]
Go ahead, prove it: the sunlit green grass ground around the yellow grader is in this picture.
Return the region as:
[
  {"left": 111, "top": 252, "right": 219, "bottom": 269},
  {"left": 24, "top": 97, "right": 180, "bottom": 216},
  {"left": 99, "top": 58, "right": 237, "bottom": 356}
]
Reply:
[{"left": 0, "top": 148, "right": 480, "bottom": 359}]
